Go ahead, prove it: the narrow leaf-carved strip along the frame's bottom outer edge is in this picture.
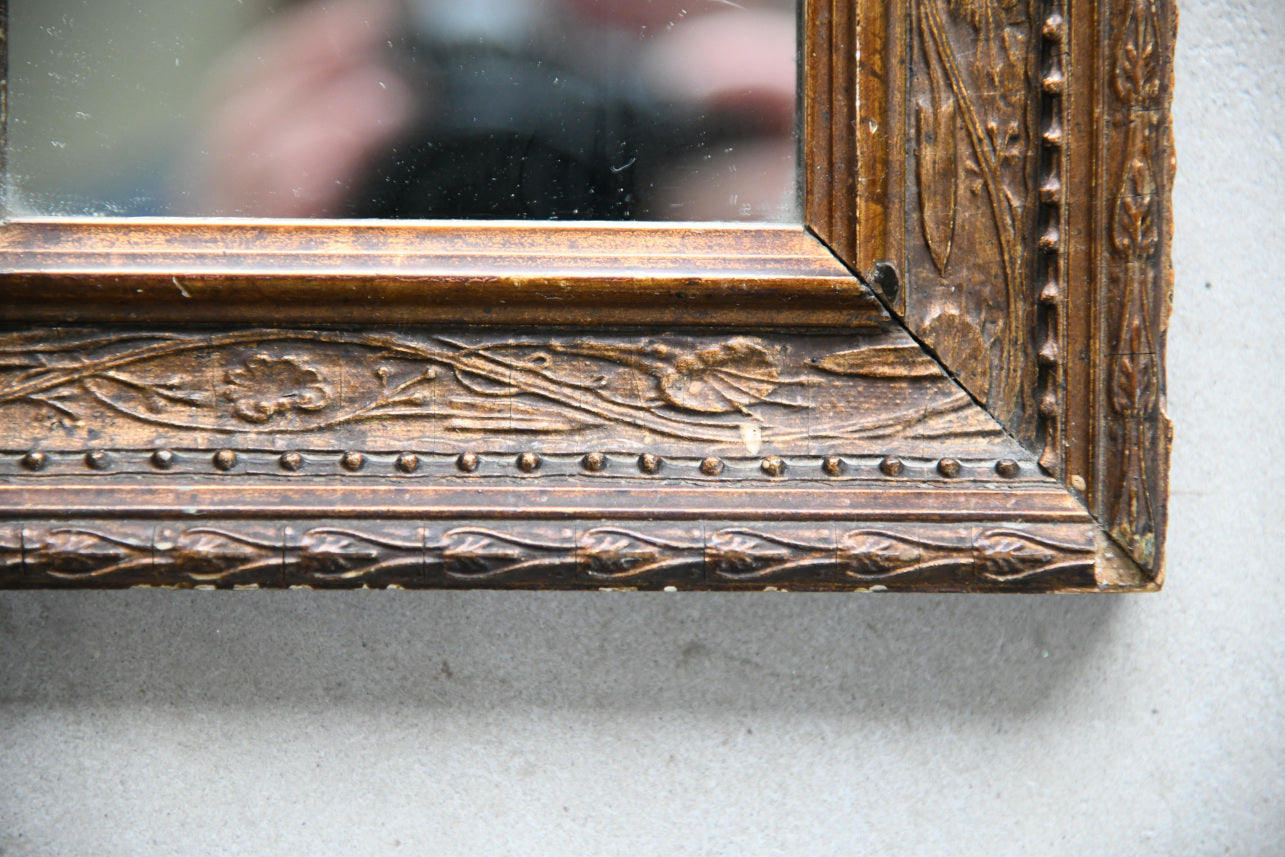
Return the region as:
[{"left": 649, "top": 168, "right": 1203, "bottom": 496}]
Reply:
[{"left": 0, "top": 520, "right": 1096, "bottom": 587}]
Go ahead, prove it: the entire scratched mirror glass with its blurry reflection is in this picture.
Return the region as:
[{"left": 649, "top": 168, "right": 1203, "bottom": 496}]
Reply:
[{"left": 5, "top": 0, "right": 798, "bottom": 221}]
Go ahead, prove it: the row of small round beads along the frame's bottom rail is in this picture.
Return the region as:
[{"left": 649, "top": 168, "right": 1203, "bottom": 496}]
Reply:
[{"left": 19, "top": 450, "right": 1022, "bottom": 479}]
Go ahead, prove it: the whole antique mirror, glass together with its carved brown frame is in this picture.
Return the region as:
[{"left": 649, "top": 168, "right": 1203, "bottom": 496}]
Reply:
[{"left": 0, "top": 0, "right": 1176, "bottom": 591}]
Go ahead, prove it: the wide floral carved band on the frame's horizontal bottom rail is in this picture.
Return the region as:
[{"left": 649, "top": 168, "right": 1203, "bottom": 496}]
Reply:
[{"left": 0, "top": 330, "right": 1001, "bottom": 454}]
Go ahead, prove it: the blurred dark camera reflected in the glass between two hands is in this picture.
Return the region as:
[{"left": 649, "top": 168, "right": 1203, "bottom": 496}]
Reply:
[{"left": 347, "top": 0, "right": 711, "bottom": 220}]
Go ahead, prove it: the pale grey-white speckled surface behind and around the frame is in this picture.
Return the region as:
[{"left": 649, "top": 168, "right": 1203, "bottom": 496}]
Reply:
[{"left": 0, "top": 0, "right": 1285, "bottom": 857}]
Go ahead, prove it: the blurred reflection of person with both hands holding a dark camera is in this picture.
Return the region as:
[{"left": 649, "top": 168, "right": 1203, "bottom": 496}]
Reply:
[{"left": 180, "top": 0, "right": 795, "bottom": 220}]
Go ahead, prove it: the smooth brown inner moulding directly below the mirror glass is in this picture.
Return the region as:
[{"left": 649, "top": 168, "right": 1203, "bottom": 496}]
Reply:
[{"left": 0, "top": 218, "right": 885, "bottom": 328}]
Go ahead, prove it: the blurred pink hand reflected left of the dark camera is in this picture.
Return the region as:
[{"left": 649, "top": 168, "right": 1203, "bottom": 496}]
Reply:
[{"left": 188, "top": 0, "right": 418, "bottom": 217}]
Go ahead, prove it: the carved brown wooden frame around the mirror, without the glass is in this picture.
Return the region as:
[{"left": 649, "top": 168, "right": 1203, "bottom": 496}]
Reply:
[{"left": 0, "top": 0, "right": 1176, "bottom": 591}]
